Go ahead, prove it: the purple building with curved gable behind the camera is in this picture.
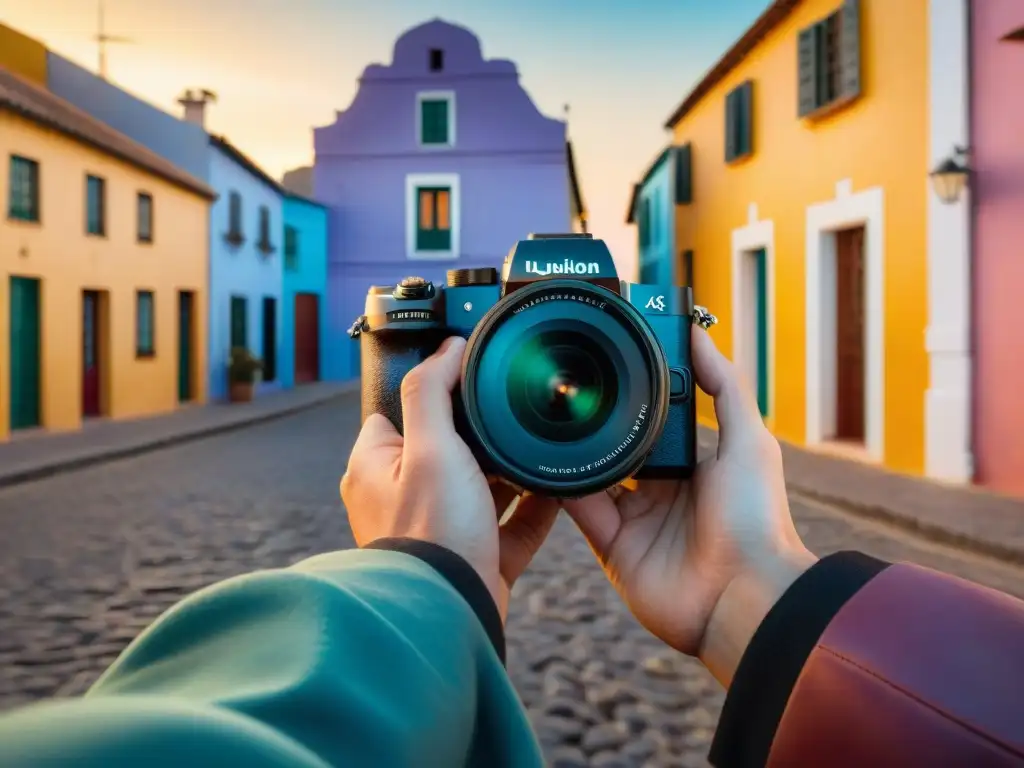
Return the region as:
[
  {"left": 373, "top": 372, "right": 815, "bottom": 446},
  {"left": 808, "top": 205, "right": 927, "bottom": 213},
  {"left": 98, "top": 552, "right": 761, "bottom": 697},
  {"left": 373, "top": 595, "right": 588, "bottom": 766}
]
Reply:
[{"left": 313, "top": 19, "right": 586, "bottom": 378}]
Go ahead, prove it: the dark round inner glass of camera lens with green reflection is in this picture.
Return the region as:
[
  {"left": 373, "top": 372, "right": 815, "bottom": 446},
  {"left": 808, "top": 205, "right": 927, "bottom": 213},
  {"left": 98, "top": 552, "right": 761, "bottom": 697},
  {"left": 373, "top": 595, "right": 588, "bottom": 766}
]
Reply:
[{"left": 506, "top": 331, "right": 618, "bottom": 442}]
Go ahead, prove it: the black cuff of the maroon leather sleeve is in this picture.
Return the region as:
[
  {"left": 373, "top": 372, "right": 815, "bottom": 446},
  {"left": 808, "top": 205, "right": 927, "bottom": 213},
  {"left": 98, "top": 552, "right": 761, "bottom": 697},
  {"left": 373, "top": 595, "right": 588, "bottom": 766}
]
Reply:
[{"left": 708, "top": 552, "right": 889, "bottom": 768}]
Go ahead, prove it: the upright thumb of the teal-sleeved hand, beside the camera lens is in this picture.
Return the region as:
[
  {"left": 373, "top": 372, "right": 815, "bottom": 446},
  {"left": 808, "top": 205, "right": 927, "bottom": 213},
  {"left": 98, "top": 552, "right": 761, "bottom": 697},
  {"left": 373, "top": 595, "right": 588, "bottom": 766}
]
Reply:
[{"left": 401, "top": 336, "right": 466, "bottom": 446}]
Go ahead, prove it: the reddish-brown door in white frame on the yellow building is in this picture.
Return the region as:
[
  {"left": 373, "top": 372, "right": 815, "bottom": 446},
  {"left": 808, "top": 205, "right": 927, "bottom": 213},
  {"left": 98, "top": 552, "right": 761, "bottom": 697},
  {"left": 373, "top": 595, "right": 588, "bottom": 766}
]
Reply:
[{"left": 836, "top": 227, "right": 864, "bottom": 442}]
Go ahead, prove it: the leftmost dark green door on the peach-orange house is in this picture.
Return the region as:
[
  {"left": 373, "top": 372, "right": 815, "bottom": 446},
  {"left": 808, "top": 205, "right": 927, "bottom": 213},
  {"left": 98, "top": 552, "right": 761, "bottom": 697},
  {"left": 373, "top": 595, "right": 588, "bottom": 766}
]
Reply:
[{"left": 10, "top": 278, "right": 40, "bottom": 429}]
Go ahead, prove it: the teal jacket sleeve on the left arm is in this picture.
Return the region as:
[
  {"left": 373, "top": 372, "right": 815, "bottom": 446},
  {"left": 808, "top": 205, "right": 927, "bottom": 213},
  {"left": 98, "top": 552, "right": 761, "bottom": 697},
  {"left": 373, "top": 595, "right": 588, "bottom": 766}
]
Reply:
[{"left": 0, "top": 542, "right": 543, "bottom": 768}]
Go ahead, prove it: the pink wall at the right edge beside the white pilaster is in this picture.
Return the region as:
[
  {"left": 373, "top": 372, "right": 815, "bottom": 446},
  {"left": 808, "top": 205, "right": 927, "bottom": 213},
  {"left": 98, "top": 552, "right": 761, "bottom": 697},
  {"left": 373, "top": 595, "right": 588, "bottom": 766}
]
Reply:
[{"left": 971, "top": 0, "right": 1024, "bottom": 495}]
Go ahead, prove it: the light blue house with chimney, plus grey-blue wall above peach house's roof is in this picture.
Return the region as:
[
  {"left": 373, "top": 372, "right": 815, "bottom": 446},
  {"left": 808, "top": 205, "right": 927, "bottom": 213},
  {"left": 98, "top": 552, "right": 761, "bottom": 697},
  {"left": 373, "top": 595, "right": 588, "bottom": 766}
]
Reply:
[{"left": 47, "top": 52, "right": 294, "bottom": 400}]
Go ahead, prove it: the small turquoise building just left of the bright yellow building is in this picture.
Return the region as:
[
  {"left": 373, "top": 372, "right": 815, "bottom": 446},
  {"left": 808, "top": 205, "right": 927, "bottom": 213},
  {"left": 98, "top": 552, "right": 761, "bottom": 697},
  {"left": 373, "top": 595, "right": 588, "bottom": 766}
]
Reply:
[{"left": 626, "top": 144, "right": 693, "bottom": 285}]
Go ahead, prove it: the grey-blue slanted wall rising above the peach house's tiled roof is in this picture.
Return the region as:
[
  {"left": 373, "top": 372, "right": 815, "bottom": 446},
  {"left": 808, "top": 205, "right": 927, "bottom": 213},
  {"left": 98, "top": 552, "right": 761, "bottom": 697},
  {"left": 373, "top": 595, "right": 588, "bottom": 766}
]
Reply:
[{"left": 48, "top": 52, "right": 210, "bottom": 181}]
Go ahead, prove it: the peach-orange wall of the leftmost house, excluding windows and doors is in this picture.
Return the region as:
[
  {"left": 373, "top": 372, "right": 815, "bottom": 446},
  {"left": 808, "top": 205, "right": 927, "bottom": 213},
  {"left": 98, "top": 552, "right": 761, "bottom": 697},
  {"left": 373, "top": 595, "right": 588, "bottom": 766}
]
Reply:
[{"left": 0, "top": 112, "right": 209, "bottom": 435}]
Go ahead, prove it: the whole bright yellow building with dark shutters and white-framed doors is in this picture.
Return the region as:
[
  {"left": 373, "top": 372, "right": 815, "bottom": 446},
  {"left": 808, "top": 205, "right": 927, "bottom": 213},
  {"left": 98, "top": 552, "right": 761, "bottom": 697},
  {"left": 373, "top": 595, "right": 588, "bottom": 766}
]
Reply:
[{"left": 667, "top": 0, "right": 970, "bottom": 479}]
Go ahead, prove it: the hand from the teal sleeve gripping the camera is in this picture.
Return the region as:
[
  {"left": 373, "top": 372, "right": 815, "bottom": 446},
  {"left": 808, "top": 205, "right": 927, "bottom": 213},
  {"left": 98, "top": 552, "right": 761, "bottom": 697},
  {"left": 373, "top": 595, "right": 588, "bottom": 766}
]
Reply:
[{"left": 341, "top": 337, "right": 558, "bottom": 621}]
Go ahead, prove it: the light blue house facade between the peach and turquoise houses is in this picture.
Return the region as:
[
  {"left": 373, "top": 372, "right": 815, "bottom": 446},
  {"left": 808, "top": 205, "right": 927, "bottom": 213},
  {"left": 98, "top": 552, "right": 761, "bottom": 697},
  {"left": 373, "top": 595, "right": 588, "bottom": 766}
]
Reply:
[{"left": 209, "top": 136, "right": 284, "bottom": 400}]
